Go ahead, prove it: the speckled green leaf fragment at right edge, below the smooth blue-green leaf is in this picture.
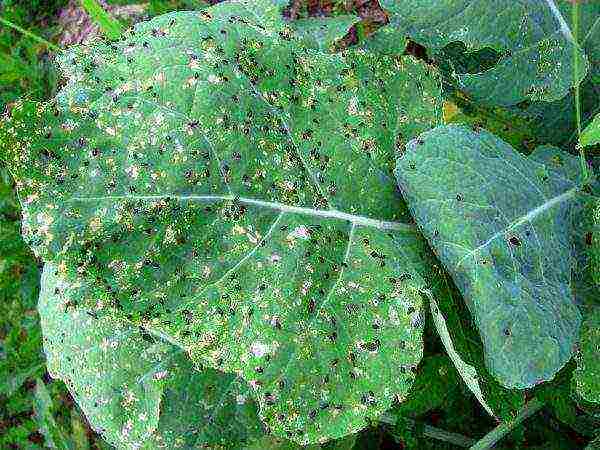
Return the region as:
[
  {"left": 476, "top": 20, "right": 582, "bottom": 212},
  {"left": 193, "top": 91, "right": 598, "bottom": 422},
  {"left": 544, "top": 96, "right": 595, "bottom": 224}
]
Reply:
[{"left": 573, "top": 307, "right": 600, "bottom": 403}]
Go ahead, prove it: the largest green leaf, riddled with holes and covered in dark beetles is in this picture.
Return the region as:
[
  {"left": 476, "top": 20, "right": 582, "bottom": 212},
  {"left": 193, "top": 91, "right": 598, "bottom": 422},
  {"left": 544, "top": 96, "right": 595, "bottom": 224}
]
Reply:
[{"left": 3, "top": 2, "right": 440, "bottom": 443}]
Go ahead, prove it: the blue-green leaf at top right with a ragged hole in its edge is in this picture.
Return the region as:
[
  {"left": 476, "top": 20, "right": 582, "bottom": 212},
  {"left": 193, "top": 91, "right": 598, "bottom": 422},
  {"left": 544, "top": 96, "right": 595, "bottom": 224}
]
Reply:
[{"left": 381, "top": 0, "right": 588, "bottom": 105}]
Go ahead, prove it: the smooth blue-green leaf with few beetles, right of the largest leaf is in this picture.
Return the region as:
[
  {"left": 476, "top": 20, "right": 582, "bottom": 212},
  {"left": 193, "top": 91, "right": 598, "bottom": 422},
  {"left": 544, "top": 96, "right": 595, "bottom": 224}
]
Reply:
[{"left": 396, "top": 126, "right": 581, "bottom": 389}]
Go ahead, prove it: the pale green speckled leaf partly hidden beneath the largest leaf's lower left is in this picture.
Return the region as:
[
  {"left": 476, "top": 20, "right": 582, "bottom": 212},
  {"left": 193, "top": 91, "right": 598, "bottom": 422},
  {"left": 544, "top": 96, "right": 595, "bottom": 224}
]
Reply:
[{"left": 39, "top": 265, "right": 262, "bottom": 449}]
